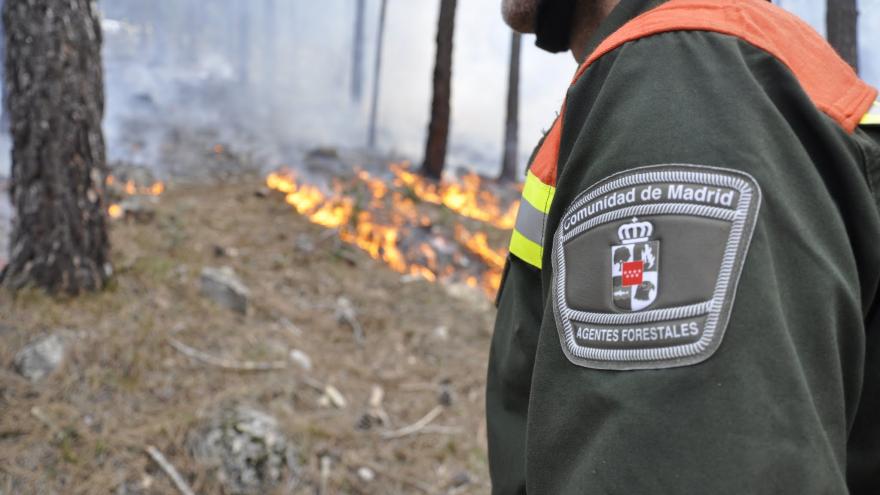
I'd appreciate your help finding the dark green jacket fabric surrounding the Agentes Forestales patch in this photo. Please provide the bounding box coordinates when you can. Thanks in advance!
[487,0,880,495]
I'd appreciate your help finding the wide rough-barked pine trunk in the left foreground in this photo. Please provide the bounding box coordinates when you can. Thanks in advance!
[0,0,111,294]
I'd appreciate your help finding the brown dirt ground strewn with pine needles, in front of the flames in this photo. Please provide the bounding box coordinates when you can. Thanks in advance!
[0,177,494,494]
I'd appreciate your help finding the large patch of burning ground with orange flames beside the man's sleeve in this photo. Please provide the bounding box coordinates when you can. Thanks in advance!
[266,165,518,294]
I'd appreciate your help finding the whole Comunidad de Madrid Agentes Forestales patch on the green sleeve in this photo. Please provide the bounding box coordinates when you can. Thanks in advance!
[551,165,761,370]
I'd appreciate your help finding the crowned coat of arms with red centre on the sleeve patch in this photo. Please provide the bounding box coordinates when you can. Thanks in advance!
[611,218,660,311]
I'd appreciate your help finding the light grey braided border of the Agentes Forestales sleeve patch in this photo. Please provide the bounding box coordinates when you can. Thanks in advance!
[551,164,761,371]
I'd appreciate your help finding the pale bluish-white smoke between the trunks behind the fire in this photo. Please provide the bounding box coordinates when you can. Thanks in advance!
[94,0,575,178]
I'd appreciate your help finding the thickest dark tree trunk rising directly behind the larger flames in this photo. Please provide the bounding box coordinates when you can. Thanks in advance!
[422,0,456,179]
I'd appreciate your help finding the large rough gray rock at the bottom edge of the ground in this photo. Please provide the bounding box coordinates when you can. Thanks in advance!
[187,405,298,495]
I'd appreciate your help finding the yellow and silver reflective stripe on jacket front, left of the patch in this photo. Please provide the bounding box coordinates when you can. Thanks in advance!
[510,171,556,269]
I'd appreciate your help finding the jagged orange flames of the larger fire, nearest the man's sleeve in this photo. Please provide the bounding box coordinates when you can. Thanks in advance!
[266,165,518,294]
